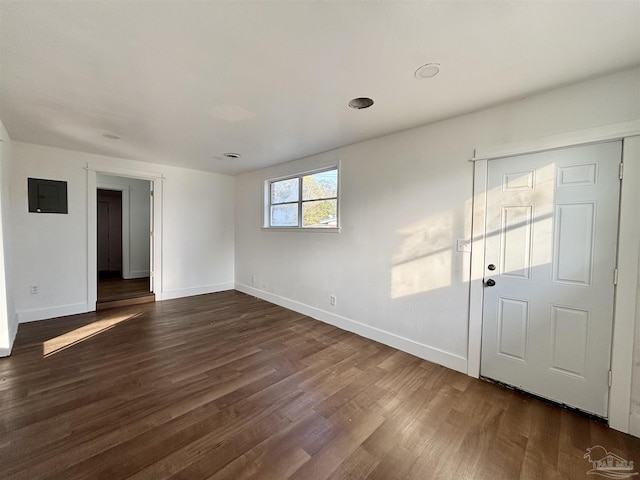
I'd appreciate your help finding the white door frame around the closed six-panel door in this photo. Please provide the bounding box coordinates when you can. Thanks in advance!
[467,120,640,433]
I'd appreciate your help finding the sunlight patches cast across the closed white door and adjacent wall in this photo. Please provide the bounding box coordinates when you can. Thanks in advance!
[391,163,555,298]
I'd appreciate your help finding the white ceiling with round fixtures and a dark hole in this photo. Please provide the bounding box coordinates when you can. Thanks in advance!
[0,0,640,174]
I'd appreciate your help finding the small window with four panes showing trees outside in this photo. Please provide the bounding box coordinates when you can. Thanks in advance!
[265,167,338,228]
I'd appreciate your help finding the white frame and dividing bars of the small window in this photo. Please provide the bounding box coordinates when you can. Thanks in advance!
[262,162,341,233]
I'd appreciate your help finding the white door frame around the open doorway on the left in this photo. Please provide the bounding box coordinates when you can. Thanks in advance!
[86,163,165,311]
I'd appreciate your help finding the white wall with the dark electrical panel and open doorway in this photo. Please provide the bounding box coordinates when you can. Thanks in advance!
[11,142,234,321]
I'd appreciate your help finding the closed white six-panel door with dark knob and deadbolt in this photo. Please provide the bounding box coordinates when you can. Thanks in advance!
[480,142,622,417]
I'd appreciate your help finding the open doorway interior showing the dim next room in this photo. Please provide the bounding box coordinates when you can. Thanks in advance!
[96,174,155,310]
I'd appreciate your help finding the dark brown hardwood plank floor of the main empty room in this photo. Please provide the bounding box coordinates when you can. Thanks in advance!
[0,292,640,480]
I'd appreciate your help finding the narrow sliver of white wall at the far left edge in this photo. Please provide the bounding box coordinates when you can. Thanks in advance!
[0,117,18,356]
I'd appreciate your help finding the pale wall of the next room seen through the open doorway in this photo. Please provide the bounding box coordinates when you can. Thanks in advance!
[97,173,151,278]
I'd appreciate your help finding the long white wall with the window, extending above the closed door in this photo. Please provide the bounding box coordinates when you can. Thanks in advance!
[236,69,640,388]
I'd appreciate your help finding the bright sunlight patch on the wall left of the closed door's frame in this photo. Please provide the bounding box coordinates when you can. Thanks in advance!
[391,212,453,298]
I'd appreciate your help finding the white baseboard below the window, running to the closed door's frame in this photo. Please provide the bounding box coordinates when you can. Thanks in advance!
[235,283,467,373]
